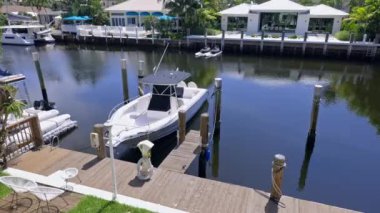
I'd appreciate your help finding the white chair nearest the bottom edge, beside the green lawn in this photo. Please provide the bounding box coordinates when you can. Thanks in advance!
[30,186,69,212]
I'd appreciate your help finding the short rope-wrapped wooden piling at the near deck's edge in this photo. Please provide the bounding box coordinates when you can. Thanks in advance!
[270,154,286,202]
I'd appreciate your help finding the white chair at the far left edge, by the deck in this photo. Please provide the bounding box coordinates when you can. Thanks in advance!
[0,176,38,208]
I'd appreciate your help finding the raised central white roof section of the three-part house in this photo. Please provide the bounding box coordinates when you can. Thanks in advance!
[250,0,309,12]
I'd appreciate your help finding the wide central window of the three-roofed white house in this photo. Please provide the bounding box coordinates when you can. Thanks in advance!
[260,13,298,32]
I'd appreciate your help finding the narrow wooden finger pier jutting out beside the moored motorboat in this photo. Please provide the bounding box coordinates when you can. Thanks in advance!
[159,130,200,173]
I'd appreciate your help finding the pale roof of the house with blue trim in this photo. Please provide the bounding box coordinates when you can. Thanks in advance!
[106,0,164,12]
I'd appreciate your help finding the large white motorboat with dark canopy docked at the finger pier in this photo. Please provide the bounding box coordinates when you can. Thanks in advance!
[108,71,207,147]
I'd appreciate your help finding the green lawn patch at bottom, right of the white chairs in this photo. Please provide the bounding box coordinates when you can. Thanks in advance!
[68,196,151,213]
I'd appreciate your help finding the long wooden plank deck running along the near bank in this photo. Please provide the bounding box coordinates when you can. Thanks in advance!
[9,147,358,213]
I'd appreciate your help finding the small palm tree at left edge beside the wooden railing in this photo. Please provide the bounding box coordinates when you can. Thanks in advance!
[0,85,24,168]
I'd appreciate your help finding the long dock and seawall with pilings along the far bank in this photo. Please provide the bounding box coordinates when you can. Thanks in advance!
[53,31,380,60]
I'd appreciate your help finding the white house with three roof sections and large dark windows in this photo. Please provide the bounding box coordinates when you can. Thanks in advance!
[219,0,348,35]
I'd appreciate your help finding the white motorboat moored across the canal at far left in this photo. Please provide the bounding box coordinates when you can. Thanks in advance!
[0,24,55,45]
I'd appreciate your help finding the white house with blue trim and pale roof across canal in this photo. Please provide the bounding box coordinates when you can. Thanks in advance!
[106,0,167,27]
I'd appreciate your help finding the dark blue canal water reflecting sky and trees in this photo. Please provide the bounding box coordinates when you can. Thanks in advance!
[0,45,380,212]
